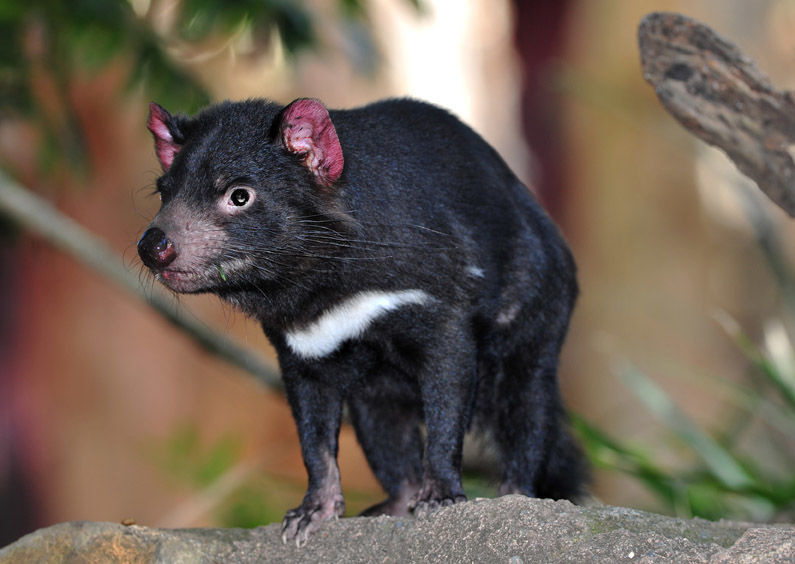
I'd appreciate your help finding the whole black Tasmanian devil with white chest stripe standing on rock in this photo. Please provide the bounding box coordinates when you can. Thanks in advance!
[138,99,586,543]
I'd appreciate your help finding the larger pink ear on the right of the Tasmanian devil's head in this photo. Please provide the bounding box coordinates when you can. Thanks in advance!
[281,98,345,186]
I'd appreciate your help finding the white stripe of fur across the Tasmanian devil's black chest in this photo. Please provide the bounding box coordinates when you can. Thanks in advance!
[286,290,431,358]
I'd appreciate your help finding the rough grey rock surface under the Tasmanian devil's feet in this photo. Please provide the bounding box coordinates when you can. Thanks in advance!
[0,496,795,564]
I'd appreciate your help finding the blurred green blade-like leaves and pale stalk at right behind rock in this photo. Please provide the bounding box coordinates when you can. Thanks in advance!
[573,169,795,521]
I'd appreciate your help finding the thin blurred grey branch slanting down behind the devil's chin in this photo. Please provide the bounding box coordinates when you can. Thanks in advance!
[0,170,281,388]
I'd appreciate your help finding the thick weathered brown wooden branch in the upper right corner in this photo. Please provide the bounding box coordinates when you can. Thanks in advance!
[638,13,795,217]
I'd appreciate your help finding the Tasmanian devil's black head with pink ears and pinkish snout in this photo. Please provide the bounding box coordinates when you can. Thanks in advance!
[138,99,343,292]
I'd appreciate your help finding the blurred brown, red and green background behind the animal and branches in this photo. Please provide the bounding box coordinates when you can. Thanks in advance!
[0,0,795,546]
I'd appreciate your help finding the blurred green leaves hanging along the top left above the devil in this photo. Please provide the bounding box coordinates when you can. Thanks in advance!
[0,0,419,178]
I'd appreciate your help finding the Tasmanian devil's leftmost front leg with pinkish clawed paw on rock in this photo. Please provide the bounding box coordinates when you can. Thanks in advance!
[282,368,345,545]
